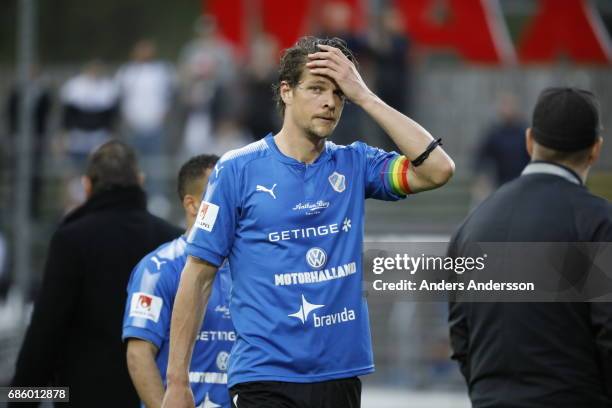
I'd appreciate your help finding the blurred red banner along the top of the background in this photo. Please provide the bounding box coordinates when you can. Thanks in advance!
[205,0,612,64]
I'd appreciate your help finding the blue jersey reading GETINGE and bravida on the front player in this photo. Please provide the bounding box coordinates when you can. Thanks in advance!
[186,134,403,387]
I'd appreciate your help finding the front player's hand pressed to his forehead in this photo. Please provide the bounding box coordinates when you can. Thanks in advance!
[306,44,371,104]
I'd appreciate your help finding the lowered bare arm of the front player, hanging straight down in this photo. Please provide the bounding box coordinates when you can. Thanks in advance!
[162,256,217,408]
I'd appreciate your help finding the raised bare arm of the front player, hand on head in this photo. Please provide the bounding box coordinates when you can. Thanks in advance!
[306,44,455,193]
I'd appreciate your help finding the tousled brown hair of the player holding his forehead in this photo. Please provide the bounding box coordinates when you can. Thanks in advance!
[272,37,357,116]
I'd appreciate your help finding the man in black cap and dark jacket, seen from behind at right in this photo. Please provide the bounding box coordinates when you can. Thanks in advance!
[449,88,612,408]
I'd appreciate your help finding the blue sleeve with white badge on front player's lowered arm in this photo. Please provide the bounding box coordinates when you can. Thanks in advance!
[186,158,240,266]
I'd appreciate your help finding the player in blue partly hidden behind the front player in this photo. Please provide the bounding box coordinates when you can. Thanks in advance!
[123,155,235,408]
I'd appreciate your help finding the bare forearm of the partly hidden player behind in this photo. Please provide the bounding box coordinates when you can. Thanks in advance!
[127,338,164,408]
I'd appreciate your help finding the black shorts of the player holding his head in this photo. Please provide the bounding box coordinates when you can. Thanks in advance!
[230,377,361,408]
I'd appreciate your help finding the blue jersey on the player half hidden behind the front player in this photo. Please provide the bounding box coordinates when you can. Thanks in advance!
[122,237,236,408]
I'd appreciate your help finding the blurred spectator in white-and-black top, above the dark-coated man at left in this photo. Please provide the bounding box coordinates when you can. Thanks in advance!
[60,61,118,169]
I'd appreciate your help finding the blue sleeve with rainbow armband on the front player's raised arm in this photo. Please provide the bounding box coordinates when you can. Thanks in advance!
[353,142,408,201]
